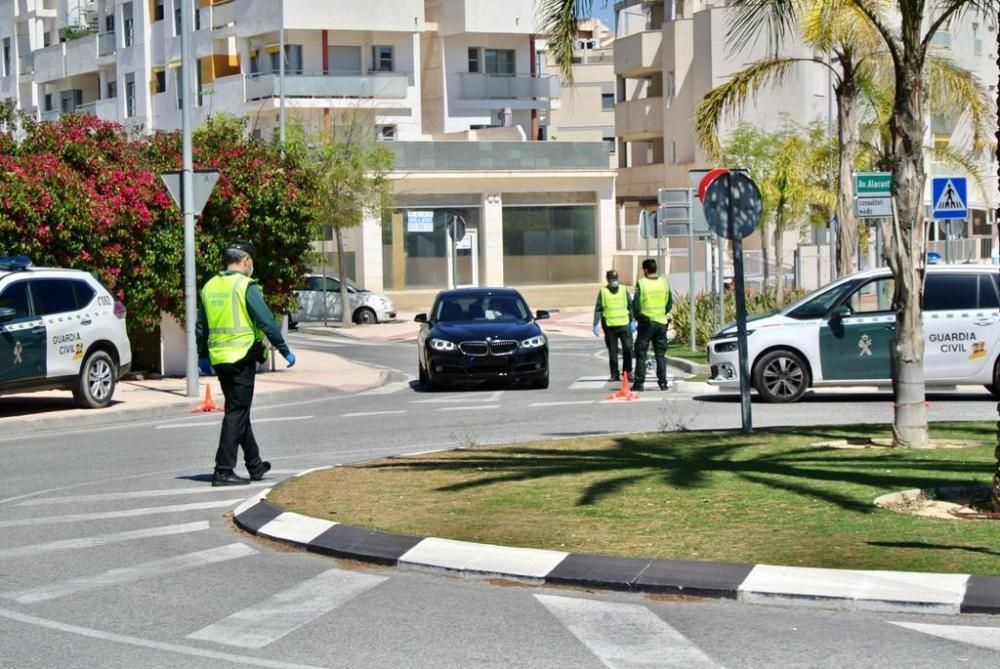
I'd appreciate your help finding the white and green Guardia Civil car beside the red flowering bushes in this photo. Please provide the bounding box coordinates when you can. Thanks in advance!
[0,256,132,408]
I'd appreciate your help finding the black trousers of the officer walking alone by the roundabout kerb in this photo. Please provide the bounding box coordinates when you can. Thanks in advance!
[215,354,260,471]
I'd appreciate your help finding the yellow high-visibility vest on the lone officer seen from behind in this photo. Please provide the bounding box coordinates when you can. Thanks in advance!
[201,272,261,365]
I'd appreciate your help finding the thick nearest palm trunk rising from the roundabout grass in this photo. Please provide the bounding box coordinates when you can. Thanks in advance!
[888,53,928,447]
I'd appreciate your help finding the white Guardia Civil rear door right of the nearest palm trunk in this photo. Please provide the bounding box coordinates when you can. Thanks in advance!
[923,272,1000,381]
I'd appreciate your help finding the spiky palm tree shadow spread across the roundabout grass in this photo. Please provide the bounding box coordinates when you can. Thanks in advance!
[361,427,989,513]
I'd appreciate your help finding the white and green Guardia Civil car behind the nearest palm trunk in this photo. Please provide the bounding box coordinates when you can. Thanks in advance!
[708,265,1000,402]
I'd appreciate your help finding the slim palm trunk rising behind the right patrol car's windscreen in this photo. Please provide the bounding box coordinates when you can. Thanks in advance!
[835,76,858,276]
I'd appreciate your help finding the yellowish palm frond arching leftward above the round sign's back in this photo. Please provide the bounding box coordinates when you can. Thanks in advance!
[695,58,815,158]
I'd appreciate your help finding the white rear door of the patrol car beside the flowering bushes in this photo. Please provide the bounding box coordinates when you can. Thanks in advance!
[29,278,87,379]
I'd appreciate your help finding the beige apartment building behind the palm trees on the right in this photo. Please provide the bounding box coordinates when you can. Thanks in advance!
[614,0,1000,272]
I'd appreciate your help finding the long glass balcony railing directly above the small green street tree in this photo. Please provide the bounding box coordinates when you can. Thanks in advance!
[246,72,409,100]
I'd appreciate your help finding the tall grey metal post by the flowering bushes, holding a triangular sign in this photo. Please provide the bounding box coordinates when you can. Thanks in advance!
[181,0,198,397]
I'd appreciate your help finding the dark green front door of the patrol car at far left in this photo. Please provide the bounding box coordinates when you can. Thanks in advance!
[0,280,46,389]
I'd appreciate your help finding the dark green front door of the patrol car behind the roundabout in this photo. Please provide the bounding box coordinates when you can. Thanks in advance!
[819,276,896,381]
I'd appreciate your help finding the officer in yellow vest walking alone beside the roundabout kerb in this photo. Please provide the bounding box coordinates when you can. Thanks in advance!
[195,241,295,486]
